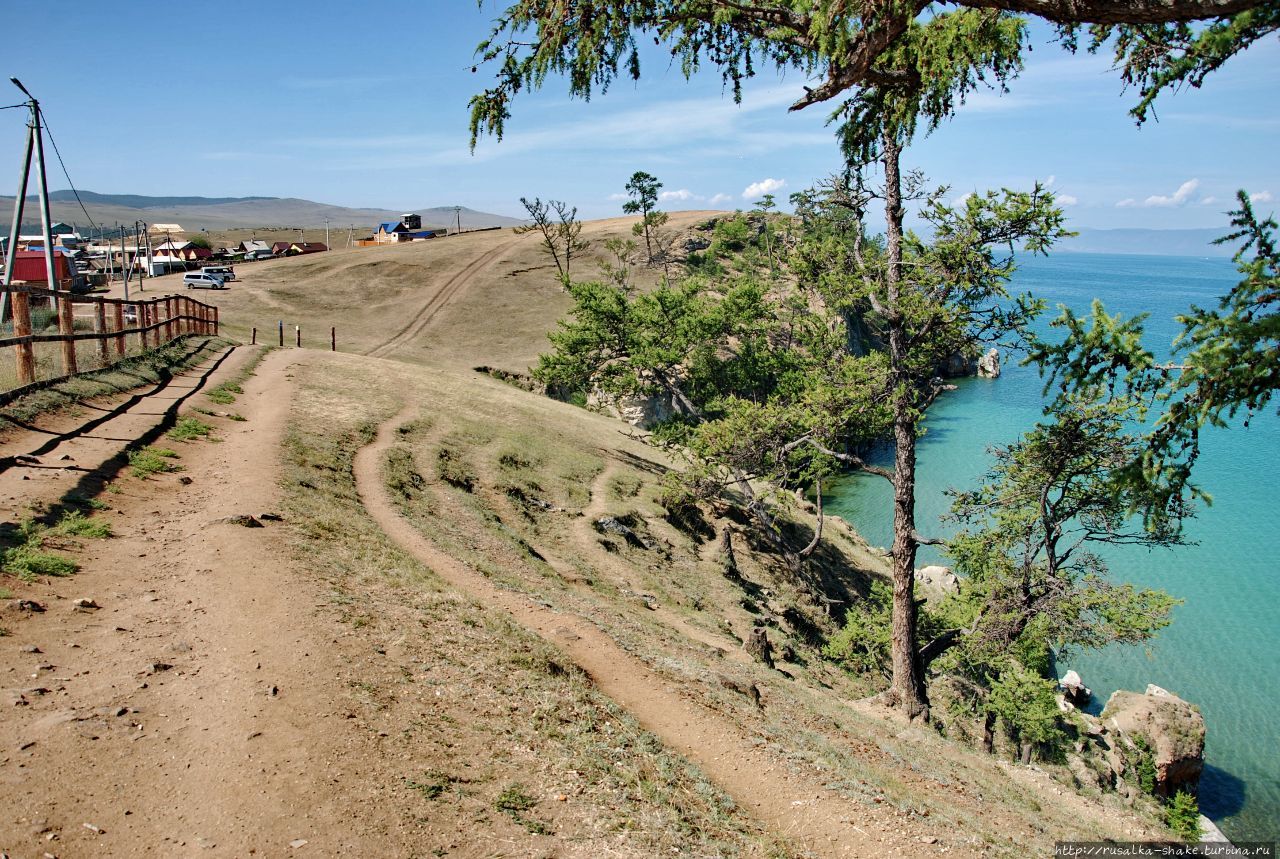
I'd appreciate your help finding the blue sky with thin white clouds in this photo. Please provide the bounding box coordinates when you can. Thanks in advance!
[0,0,1280,228]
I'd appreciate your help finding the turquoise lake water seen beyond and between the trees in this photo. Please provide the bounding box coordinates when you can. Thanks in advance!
[828,253,1280,840]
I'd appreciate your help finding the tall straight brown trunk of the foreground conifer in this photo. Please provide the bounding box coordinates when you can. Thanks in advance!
[881,133,929,721]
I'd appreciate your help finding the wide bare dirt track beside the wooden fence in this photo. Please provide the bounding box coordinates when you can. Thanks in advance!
[0,349,407,856]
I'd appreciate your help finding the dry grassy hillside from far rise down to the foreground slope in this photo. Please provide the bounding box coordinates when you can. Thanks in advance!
[87,213,1177,856]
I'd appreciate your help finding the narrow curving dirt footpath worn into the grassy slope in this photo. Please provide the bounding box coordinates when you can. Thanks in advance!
[355,405,963,856]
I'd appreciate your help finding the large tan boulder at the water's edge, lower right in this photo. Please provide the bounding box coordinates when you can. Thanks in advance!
[1102,686,1204,796]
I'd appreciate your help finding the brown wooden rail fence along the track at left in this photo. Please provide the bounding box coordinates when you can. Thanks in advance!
[0,284,218,402]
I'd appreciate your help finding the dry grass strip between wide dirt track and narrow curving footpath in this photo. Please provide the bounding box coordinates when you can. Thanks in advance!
[285,357,796,856]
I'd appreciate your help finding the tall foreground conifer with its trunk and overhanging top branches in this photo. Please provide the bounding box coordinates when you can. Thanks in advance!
[471,0,1264,717]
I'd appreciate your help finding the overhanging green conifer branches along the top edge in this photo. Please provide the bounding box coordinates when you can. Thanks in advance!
[471,0,1264,145]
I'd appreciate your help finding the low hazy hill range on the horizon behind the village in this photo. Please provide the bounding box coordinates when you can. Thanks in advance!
[0,191,524,234]
